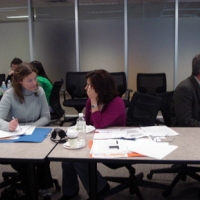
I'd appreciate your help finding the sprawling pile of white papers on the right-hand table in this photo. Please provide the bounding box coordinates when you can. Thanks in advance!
[90,126,178,159]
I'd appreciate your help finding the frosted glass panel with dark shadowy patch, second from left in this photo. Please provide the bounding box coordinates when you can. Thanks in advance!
[33,0,76,82]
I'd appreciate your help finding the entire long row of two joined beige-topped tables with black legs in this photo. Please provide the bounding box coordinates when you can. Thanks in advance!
[0,127,200,200]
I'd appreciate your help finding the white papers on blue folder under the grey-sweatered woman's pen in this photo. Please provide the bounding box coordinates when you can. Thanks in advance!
[0,125,35,139]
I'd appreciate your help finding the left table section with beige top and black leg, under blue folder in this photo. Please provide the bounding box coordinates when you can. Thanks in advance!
[0,131,56,200]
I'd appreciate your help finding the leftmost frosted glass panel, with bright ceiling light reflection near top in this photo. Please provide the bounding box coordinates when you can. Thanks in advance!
[0,0,29,76]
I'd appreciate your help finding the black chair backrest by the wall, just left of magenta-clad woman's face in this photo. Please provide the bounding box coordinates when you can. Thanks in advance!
[65,72,88,99]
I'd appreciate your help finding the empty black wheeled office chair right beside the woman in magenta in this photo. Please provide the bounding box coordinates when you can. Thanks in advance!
[101,92,167,200]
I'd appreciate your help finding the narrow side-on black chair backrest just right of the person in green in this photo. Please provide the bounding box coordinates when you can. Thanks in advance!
[49,79,65,119]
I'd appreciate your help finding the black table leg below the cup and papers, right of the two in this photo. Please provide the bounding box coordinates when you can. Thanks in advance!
[89,162,98,200]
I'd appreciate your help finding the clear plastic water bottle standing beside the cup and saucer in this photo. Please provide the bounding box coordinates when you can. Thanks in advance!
[76,113,86,147]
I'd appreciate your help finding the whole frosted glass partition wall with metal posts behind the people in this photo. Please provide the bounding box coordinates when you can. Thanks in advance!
[0,0,200,91]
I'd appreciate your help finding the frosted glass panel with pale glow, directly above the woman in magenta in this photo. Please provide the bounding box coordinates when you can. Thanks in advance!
[79,0,124,72]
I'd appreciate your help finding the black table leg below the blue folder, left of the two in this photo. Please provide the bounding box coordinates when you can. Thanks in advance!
[28,163,38,200]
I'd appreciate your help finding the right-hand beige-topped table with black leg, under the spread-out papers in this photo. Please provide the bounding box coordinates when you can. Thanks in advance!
[48,128,200,200]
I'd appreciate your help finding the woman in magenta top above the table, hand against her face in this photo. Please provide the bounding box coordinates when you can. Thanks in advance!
[85,70,126,128]
